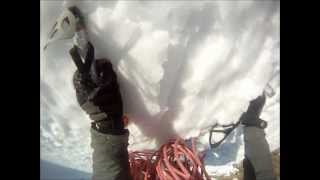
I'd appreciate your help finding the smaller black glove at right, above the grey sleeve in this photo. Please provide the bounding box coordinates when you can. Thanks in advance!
[240,94,267,129]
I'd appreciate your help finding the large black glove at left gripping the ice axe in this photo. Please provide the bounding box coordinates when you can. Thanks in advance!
[70,43,125,135]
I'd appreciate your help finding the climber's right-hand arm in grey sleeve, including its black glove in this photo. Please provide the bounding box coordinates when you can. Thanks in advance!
[241,95,275,180]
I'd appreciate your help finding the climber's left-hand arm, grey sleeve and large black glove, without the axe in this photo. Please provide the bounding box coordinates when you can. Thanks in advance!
[70,36,130,180]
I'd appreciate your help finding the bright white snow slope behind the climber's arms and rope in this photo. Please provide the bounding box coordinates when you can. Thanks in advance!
[40,1,280,174]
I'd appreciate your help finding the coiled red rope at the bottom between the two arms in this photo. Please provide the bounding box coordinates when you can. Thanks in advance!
[129,138,210,180]
